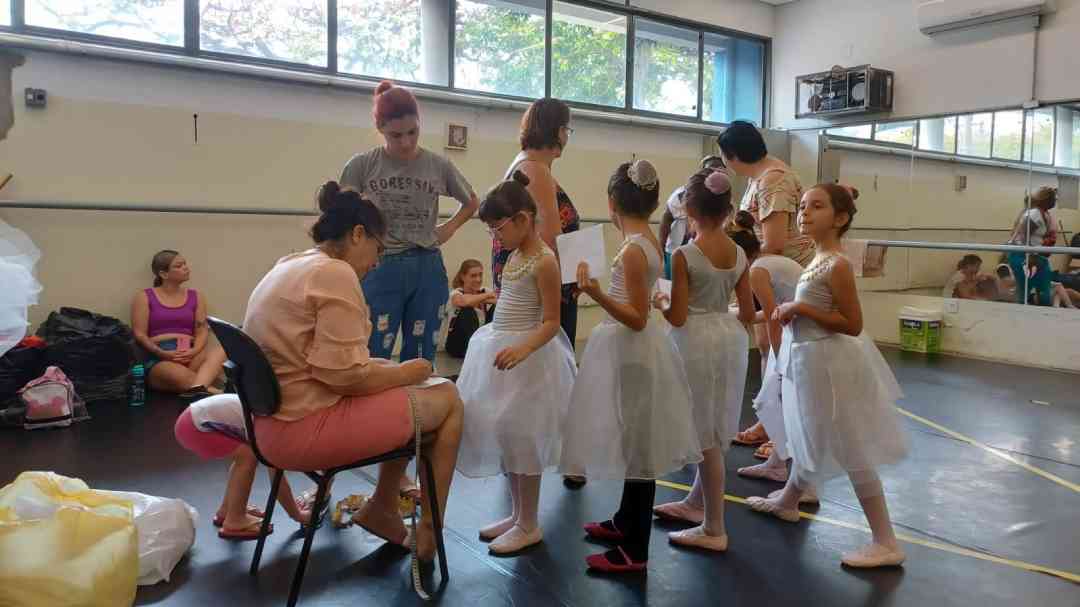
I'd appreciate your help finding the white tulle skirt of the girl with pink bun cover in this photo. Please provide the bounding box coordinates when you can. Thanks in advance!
[669,314,750,450]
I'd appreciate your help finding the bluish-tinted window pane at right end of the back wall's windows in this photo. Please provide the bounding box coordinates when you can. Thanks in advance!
[701,33,765,126]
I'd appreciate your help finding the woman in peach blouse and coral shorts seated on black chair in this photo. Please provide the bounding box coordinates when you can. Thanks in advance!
[244,181,462,561]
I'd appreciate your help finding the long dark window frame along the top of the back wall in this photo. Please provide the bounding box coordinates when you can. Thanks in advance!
[0,0,772,127]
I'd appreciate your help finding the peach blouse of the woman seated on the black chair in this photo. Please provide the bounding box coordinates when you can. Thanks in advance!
[244,248,372,421]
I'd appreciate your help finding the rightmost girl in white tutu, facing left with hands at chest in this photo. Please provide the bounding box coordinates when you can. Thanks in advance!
[747,184,907,567]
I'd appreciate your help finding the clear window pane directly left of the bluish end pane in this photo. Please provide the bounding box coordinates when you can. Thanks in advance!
[634,19,698,116]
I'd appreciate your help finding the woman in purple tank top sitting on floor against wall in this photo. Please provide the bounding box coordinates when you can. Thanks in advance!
[132,249,225,399]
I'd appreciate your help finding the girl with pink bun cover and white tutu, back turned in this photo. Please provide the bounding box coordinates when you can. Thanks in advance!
[653,170,754,552]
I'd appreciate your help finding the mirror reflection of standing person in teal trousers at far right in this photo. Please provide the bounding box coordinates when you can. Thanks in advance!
[1008,187,1057,306]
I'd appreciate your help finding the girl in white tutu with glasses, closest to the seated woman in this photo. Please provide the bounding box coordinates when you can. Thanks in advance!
[458,171,577,554]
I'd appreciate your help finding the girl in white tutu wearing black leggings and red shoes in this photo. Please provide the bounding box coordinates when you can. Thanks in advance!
[559,160,701,572]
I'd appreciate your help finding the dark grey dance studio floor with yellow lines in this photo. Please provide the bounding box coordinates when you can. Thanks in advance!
[0,350,1080,607]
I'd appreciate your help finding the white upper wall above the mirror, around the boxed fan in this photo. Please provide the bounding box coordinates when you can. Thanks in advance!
[771,0,1080,127]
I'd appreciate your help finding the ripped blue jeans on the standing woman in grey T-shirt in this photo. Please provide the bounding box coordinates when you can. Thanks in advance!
[361,248,450,364]
